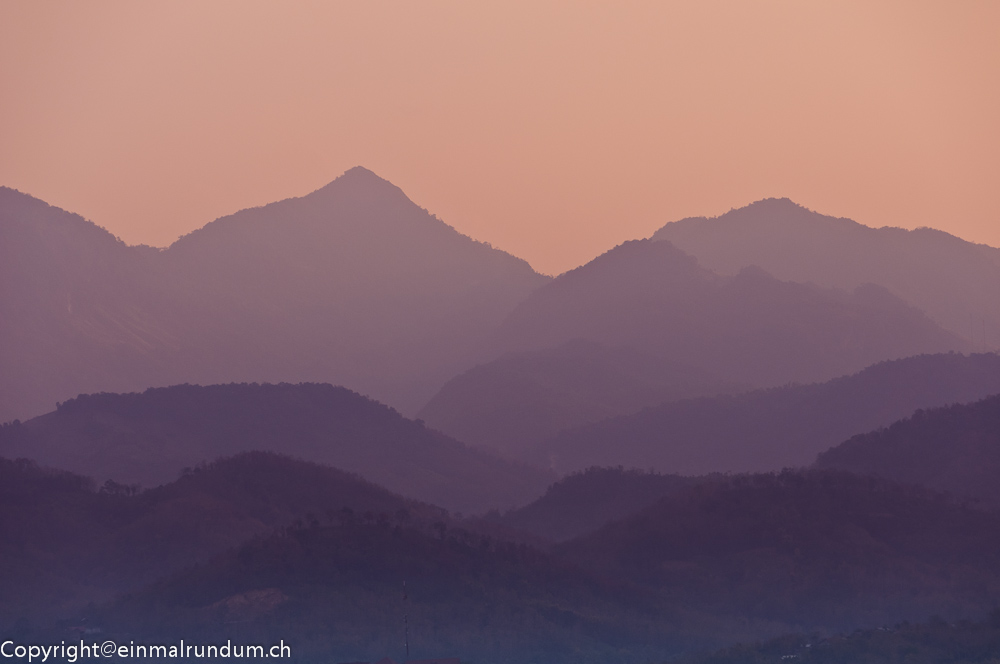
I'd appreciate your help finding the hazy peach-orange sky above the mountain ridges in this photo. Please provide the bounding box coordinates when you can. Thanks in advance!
[0,0,1000,273]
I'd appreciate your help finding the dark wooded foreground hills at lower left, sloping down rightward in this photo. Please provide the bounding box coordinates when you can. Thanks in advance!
[0,452,752,664]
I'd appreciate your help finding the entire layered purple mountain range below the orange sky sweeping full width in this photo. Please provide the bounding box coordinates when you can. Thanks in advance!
[0,167,1000,664]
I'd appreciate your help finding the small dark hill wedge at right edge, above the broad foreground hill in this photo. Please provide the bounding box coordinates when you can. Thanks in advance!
[816,395,1000,507]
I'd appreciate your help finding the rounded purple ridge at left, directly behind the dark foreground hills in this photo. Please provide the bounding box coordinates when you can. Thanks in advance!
[0,384,552,511]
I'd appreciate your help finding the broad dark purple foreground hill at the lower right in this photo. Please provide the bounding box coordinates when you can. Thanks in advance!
[553,471,1000,630]
